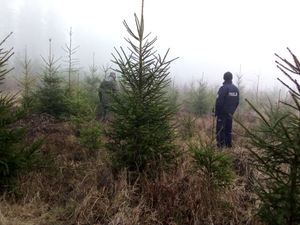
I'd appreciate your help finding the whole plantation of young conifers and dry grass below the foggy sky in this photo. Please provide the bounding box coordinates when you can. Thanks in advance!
[0,0,300,225]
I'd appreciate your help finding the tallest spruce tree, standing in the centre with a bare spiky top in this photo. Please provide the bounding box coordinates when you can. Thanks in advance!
[107,1,176,176]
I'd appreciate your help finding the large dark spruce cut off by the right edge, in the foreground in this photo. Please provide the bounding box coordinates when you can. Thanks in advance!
[242,50,300,225]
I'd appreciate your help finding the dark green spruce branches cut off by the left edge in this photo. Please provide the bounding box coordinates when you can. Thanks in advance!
[0,34,41,191]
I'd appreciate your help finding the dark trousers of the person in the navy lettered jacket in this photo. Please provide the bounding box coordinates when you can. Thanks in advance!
[216,114,232,148]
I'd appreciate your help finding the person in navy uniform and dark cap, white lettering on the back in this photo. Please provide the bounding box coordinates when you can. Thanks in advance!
[215,72,240,148]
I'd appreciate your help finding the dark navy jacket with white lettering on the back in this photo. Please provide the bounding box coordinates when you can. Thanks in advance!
[215,81,240,116]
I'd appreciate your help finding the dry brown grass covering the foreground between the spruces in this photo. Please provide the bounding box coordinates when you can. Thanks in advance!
[0,116,259,225]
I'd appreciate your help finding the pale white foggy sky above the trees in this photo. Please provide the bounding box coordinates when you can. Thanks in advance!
[0,0,300,89]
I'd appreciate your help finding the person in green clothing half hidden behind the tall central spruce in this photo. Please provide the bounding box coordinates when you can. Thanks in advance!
[99,72,117,121]
